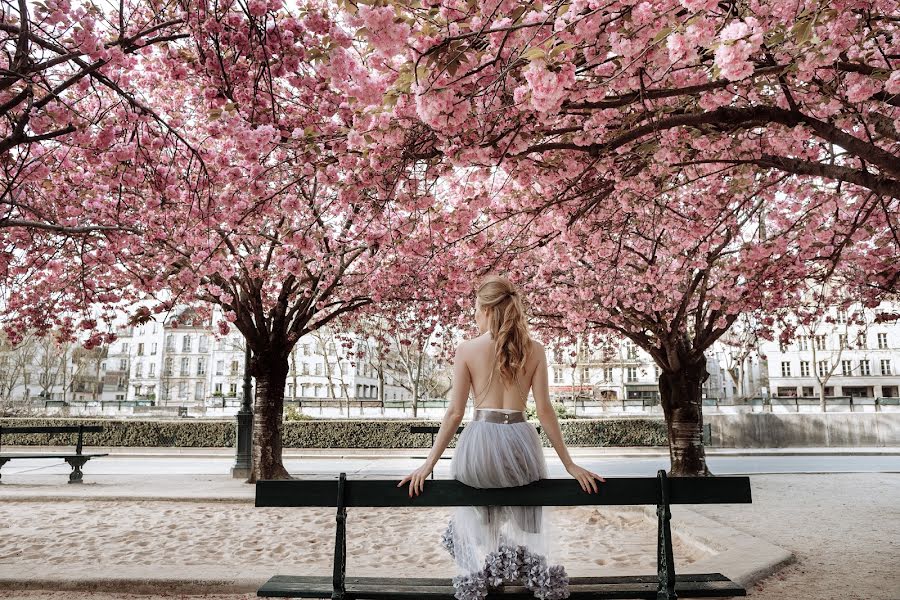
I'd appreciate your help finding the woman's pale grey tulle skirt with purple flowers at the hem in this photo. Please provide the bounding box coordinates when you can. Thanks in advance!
[441,370,569,600]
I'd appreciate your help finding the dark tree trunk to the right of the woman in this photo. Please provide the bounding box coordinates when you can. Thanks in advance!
[659,358,712,477]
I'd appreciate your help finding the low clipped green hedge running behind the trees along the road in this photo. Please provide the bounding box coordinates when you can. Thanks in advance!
[0,418,668,448]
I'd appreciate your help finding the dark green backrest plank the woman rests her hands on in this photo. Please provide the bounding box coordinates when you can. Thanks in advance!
[256,476,752,507]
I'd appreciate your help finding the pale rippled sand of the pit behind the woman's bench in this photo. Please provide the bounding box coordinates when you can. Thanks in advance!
[0,500,706,577]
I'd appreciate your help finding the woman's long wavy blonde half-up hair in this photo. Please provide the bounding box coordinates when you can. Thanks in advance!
[476,275,531,386]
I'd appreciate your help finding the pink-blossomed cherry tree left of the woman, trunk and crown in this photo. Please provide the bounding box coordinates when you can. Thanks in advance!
[4,0,428,482]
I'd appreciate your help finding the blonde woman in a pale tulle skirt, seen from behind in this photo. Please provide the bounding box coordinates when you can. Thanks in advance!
[397,275,605,600]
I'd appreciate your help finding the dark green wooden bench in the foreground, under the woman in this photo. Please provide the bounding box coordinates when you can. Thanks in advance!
[255,470,751,600]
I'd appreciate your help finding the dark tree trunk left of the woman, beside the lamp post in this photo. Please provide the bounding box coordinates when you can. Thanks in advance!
[247,353,291,483]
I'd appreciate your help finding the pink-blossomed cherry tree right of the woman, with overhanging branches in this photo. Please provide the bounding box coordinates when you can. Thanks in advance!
[345,0,900,475]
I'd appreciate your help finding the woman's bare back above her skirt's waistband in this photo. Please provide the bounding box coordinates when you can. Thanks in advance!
[465,333,539,411]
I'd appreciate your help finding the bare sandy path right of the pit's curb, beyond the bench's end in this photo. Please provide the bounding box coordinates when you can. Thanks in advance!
[691,473,900,600]
